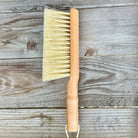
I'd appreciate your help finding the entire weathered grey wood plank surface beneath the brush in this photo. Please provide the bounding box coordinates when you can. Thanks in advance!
[0,0,138,138]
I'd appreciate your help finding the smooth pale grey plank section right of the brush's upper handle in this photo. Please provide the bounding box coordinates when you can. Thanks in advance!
[80,6,138,56]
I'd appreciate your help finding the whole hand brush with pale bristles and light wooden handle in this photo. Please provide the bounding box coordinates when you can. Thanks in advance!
[43,9,79,132]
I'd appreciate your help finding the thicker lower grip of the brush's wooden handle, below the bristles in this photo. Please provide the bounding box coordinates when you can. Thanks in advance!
[67,78,78,132]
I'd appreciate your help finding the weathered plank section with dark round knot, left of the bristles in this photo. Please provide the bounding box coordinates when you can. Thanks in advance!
[0,13,43,58]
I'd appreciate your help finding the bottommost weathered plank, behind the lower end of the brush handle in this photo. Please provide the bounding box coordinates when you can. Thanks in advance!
[0,109,138,138]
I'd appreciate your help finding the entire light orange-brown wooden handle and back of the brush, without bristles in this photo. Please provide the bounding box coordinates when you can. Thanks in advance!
[67,9,79,132]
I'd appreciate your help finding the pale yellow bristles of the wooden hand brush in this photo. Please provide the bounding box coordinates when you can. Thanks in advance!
[42,9,70,81]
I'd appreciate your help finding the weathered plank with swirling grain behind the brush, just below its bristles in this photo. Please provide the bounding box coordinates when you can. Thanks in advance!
[0,56,138,108]
